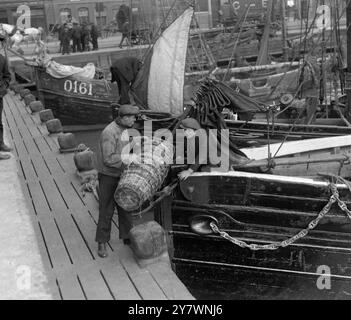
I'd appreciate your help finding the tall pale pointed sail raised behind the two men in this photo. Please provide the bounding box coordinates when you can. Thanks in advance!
[132,7,194,115]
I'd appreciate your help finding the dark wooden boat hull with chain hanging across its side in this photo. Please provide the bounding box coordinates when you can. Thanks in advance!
[158,172,351,299]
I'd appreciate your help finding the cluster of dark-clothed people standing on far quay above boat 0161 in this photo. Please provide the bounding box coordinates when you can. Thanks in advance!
[59,22,99,55]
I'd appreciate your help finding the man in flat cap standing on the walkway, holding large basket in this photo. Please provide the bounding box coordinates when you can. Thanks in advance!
[95,105,139,258]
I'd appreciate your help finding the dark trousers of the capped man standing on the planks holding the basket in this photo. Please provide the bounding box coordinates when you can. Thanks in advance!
[95,173,134,243]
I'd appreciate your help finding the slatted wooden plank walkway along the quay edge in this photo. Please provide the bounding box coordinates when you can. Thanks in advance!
[4,93,193,300]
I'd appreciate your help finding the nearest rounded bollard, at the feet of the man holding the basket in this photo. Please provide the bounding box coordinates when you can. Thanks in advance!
[129,221,167,259]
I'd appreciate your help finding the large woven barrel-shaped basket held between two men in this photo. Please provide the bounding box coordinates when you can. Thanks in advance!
[115,139,173,211]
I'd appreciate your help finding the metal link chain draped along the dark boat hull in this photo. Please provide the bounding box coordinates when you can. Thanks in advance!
[210,183,351,251]
